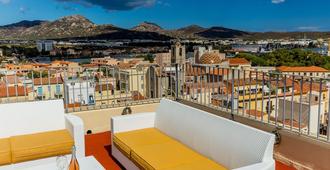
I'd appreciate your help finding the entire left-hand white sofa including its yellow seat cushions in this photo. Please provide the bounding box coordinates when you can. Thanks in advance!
[0,100,85,169]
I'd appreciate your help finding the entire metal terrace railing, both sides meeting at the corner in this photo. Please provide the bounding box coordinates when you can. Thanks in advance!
[0,64,330,142]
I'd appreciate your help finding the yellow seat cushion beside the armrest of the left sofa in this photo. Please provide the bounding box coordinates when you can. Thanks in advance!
[10,130,74,163]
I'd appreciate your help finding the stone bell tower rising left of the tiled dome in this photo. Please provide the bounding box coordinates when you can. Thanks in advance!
[171,42,186,64]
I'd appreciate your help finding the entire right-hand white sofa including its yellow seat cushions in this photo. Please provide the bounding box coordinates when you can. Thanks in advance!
[111,99,275,170]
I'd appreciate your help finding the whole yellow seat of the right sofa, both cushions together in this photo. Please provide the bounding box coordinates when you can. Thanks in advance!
[113,128,226,170]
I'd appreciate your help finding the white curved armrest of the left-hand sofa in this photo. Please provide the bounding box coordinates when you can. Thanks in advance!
[65,115,85,157]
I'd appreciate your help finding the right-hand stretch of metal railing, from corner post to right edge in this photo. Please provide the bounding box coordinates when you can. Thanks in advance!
[179,65,330,142]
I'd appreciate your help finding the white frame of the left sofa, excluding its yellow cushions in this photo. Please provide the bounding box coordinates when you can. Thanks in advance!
[0,100,85,170]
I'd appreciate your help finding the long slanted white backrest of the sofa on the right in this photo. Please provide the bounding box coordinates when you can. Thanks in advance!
[155,99,274,169]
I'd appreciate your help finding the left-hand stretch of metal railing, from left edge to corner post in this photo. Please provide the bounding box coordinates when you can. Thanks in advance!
[0,65,175,112]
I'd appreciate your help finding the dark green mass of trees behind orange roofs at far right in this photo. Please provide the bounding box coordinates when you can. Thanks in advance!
[236,49,330,69]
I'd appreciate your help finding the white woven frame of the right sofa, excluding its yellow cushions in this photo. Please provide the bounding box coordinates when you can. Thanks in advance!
[111,99,275,170]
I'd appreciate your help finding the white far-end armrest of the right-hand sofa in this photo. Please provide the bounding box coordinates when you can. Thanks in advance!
[111,112,156,134]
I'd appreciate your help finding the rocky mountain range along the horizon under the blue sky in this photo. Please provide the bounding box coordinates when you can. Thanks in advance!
[0,15,330,40]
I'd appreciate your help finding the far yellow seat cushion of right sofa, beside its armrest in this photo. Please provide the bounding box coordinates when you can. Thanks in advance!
[113,128,173,158]
